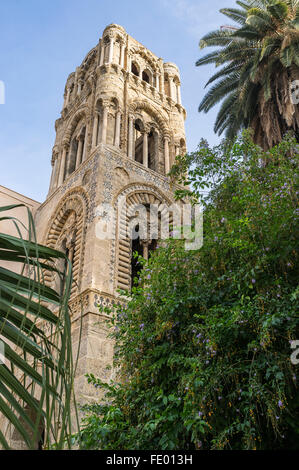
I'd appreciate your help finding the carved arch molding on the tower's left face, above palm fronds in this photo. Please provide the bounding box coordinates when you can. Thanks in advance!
[45,187,90,297]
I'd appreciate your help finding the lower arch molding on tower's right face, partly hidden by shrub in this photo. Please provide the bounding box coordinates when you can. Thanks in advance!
[112,183,173,291]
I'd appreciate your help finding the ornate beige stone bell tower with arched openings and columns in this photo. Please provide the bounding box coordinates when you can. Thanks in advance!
[36,24,186,403]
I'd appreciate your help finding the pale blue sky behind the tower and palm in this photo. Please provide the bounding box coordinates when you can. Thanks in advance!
[0,0,235,201]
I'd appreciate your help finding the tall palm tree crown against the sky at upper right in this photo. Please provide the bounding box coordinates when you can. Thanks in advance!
[196,0,299,150]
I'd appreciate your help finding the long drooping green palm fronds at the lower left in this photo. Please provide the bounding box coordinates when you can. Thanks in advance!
[0,205,78,449]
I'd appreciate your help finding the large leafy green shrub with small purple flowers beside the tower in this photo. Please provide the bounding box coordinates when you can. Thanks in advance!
[82,134,299,450]
